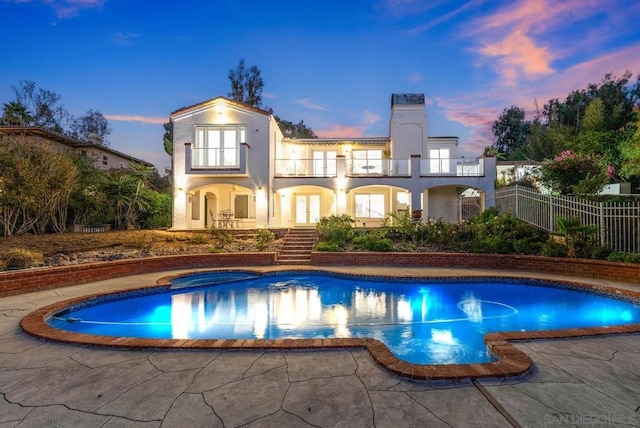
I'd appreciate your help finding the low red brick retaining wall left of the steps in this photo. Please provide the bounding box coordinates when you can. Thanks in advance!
[0,253,276,296]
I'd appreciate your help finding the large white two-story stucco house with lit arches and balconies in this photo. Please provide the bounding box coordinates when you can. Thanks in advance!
[171,94,496,230]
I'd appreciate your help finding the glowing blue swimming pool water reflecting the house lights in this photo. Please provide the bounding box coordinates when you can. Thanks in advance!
[49,272,640,364]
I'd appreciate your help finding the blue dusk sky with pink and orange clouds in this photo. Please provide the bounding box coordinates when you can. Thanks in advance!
[0,0,640,173]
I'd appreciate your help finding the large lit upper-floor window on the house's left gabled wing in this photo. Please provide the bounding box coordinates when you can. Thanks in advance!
[191,126,247,168]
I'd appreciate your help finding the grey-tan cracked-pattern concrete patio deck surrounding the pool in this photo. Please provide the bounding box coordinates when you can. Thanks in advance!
[0,268,640,427]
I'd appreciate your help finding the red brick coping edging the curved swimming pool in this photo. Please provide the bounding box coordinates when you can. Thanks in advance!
[20,267,640,380]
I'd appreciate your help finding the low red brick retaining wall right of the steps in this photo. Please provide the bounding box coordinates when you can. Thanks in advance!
[311,251,640,284]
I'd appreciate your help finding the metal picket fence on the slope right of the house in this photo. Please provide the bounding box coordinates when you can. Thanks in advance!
[495,185,640,253]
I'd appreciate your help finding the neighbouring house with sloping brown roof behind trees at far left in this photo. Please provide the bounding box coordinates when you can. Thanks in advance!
[0,126,154,171]
